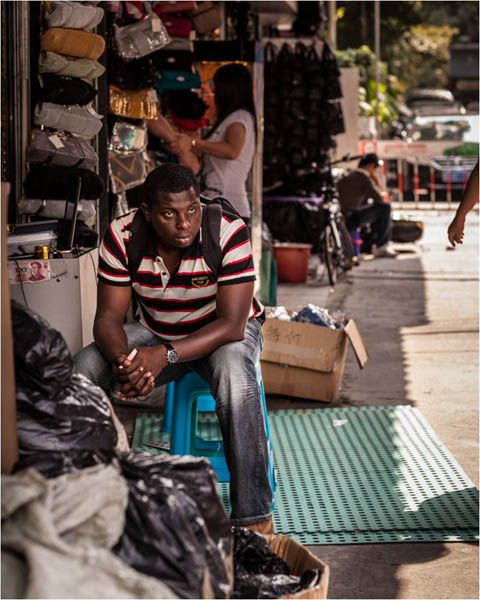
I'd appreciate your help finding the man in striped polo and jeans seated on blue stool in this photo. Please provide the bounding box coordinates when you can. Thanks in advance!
[75,164,273,533]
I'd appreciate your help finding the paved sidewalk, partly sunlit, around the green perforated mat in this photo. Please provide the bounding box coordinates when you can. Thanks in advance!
[269,211,479,599]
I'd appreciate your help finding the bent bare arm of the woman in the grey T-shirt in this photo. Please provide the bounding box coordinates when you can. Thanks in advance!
[169,123,246,160]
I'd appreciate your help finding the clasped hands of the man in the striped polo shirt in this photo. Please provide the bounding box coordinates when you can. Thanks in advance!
[113,346,167,400]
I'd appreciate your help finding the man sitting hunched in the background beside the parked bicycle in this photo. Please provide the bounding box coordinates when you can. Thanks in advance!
[337,154,397,258]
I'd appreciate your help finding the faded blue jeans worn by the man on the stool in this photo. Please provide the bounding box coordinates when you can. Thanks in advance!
[75,319,273,525]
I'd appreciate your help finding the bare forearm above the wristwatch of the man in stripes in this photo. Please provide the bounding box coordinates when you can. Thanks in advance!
[172,318,245,362]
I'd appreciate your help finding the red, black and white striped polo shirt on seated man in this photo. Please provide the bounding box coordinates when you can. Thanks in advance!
[98,209,263,340]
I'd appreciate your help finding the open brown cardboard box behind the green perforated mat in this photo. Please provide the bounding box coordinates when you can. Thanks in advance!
[262,319,368,402]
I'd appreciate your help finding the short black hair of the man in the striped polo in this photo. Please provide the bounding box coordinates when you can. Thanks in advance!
[143,163,200,206]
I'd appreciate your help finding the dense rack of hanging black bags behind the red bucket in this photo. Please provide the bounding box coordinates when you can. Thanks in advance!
[263,41,345,191]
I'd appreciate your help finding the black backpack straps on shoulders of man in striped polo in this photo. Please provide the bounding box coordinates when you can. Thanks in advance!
[126,196,241,281]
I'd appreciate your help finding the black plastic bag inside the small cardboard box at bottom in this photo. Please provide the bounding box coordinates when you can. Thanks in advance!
[232,527,321,598]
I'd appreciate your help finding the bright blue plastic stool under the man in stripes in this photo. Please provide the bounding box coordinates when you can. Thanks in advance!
[163,369,277,492]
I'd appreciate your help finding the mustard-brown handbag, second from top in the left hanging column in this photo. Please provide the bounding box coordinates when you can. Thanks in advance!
[42,27,105,60]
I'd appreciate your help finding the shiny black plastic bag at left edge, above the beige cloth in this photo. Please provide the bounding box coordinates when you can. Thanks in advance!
[12,302,117,477]
